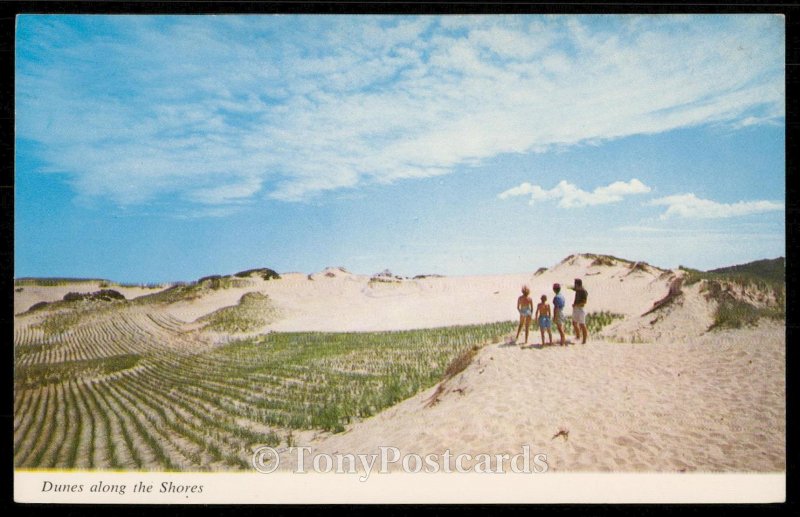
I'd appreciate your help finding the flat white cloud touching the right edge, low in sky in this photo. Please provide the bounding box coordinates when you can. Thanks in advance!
[649,194,785,220]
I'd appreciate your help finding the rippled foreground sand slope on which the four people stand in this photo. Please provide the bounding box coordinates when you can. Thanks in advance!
[282,324,785,472]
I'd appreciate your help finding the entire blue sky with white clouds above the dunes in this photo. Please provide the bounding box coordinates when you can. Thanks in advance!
[15,15,785,282]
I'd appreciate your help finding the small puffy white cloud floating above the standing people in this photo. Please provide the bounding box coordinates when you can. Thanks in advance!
[498,178,650,208]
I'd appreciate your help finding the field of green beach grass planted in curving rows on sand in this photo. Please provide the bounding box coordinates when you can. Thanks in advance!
[14,306,513,471]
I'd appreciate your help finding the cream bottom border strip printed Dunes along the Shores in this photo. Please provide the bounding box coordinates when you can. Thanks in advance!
[14,470,786,504]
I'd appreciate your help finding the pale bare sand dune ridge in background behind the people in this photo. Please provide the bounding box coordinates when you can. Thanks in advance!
[14,256,669,331]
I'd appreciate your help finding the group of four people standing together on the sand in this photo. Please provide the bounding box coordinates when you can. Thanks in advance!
[514,278,589,346]
